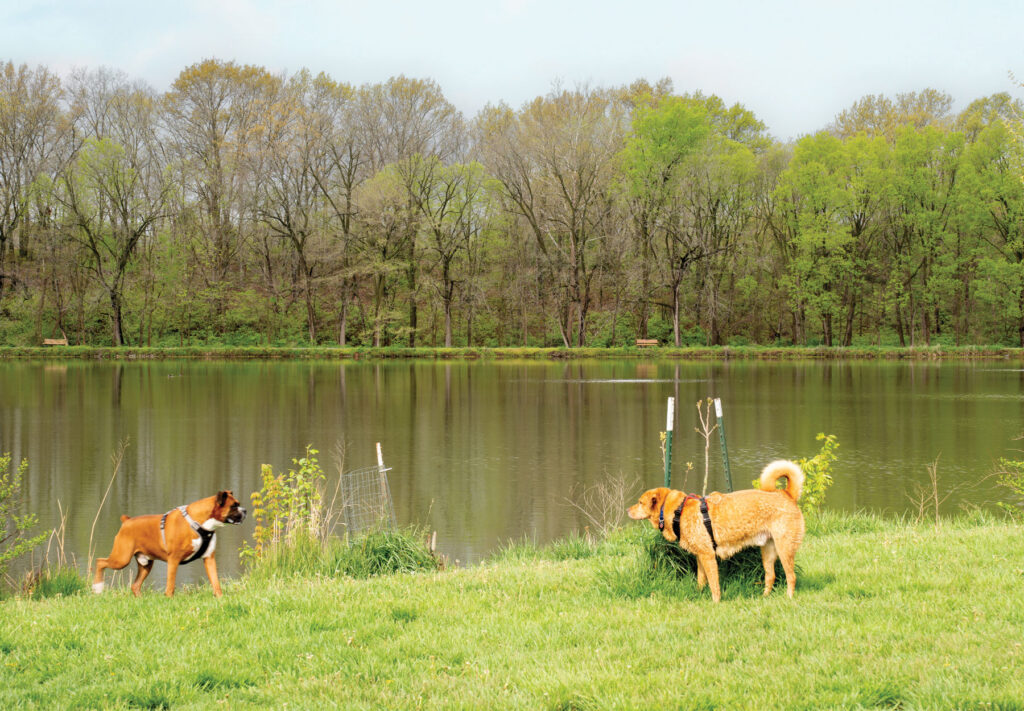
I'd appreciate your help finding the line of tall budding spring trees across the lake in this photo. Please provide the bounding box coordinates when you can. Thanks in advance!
[0,59,1024,346]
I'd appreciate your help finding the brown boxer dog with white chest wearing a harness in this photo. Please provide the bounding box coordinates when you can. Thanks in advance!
[92,491,246,597]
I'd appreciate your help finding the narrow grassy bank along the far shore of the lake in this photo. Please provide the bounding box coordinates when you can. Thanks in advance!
[6,345,1024,361]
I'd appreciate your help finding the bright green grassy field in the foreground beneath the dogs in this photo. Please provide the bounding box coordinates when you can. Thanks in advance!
[0,517,1024,709]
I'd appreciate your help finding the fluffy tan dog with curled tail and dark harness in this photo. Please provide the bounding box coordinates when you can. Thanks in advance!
[630,460,804,602]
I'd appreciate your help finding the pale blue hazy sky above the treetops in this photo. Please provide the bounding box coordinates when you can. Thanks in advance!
[0,0,1024,140]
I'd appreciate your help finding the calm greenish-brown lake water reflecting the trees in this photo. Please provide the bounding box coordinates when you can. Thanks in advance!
[0,361,1024,589]
